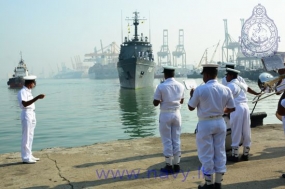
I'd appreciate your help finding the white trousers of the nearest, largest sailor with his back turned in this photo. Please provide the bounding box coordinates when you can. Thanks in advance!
[196,118,227,175]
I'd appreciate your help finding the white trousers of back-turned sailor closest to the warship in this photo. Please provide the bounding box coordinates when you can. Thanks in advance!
[159,110,181,157]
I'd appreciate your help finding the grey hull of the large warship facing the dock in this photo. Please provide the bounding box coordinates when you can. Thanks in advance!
[117,58,154,89]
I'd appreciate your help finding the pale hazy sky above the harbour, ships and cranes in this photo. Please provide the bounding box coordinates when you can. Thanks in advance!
[0,0,285,78]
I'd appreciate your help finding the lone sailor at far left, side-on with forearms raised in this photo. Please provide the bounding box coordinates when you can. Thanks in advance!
[18,75,45,164]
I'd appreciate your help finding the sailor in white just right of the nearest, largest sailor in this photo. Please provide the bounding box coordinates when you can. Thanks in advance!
[226,68,251,162]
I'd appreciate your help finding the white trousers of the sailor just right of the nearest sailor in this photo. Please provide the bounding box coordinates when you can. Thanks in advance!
[227,103,251,147]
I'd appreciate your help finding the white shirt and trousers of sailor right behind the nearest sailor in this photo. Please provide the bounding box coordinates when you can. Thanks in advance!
[227,79,251,148]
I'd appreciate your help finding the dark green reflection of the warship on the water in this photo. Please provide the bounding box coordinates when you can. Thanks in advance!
[119,88,156,138]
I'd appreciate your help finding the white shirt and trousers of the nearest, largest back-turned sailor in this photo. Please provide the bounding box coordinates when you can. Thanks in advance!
[188,80,235,175]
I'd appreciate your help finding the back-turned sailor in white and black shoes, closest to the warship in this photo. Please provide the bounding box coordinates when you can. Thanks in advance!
[153,66,185,173]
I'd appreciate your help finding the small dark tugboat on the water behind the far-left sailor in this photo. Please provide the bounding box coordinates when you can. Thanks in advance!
[7,53,29,88]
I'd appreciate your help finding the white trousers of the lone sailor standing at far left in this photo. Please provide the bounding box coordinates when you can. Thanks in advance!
[21,110,36,161]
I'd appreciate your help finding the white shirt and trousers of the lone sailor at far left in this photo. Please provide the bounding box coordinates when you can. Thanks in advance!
[18,86,36,161]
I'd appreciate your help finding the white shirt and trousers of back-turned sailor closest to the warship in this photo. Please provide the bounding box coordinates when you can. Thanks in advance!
[153,78,185,157]
